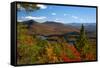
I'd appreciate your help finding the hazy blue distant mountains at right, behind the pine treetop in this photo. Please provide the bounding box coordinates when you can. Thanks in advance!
[65,23,96,39]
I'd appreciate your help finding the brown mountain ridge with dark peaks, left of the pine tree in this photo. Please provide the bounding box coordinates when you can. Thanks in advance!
[23,20,79,35]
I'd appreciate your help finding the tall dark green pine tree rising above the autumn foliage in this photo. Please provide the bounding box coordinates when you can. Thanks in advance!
[75,24,89,58]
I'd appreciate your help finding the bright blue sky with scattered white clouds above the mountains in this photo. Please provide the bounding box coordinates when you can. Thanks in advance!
[17,4,96,24]
